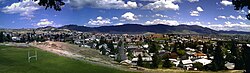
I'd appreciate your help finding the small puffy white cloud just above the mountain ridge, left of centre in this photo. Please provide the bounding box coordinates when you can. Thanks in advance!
[88,16,112,26]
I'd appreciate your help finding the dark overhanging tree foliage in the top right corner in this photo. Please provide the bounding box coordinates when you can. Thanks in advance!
[232,0,250,20]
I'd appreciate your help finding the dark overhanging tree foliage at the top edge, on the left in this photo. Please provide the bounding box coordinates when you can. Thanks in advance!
[23,0,65,11]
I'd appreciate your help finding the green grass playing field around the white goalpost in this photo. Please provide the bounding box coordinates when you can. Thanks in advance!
[0,46,135,73]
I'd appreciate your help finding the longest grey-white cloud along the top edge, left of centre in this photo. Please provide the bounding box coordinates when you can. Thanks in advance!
[68,0,138,9]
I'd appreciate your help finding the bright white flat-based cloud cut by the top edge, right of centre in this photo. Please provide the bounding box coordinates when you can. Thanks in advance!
[143,0,179,10]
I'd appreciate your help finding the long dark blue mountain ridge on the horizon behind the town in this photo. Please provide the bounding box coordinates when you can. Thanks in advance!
[56,24,250,34]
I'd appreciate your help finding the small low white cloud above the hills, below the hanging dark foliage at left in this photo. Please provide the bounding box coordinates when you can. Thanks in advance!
[34,19,56,27]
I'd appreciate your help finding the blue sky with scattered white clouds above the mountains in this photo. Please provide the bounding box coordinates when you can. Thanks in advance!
[0,0,250,32]
